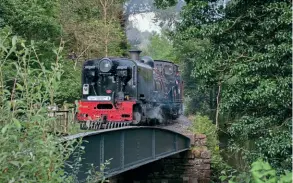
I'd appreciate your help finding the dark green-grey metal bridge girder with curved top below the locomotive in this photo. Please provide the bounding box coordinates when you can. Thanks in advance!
[65,127,190,180]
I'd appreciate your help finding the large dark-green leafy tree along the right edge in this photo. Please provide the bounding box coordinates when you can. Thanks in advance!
[217,1,292,171]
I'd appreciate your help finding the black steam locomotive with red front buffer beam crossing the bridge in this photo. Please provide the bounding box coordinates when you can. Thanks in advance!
[77,50,183,129]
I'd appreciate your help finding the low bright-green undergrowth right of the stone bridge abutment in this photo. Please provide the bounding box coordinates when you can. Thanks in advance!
[190,114,292,183]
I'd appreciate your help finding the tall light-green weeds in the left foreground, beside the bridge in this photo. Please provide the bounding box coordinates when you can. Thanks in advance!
[0,28,107,183]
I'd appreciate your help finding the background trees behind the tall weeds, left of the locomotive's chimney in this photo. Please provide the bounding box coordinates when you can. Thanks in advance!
[0,0,128,104]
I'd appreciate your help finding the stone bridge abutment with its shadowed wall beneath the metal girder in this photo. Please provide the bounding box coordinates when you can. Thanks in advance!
[110,134,211,183]
